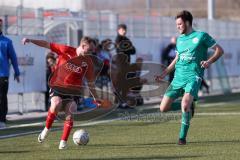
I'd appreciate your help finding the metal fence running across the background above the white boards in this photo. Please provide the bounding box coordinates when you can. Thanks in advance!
[2,7,240,41]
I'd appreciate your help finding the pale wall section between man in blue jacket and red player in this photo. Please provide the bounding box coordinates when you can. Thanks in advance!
[8,36,46,93]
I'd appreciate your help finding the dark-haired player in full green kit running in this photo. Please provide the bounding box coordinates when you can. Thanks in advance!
[156,11,223,145]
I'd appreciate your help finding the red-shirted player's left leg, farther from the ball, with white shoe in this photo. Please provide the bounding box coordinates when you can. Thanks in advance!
[38,96,62,143]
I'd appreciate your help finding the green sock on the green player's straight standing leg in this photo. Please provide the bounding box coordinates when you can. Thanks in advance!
[179,112,191,139]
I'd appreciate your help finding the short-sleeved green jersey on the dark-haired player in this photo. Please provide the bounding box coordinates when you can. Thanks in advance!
[173,31,216,87]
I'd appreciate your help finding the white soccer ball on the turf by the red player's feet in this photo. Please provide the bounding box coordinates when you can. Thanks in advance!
[73,129,89,146]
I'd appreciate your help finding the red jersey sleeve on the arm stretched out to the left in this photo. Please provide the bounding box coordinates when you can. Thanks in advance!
[50,43,76,56]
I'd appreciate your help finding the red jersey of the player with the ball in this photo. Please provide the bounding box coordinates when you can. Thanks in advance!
[49,43,95,94]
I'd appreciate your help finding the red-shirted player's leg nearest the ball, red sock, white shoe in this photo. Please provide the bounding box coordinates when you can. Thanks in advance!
[59,100,77,149]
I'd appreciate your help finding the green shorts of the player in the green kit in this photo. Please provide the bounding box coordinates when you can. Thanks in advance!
[164,80,202,101]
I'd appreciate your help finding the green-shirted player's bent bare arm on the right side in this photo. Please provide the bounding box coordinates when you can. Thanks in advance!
[201,44,224,68]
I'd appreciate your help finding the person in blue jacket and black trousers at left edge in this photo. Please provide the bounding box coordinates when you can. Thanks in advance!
[0,19,20,128]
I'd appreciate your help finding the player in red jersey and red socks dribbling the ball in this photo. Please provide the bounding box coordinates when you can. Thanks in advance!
[22,37,97,149]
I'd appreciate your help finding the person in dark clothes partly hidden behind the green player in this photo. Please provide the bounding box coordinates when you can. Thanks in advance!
[162,37,176,82]
